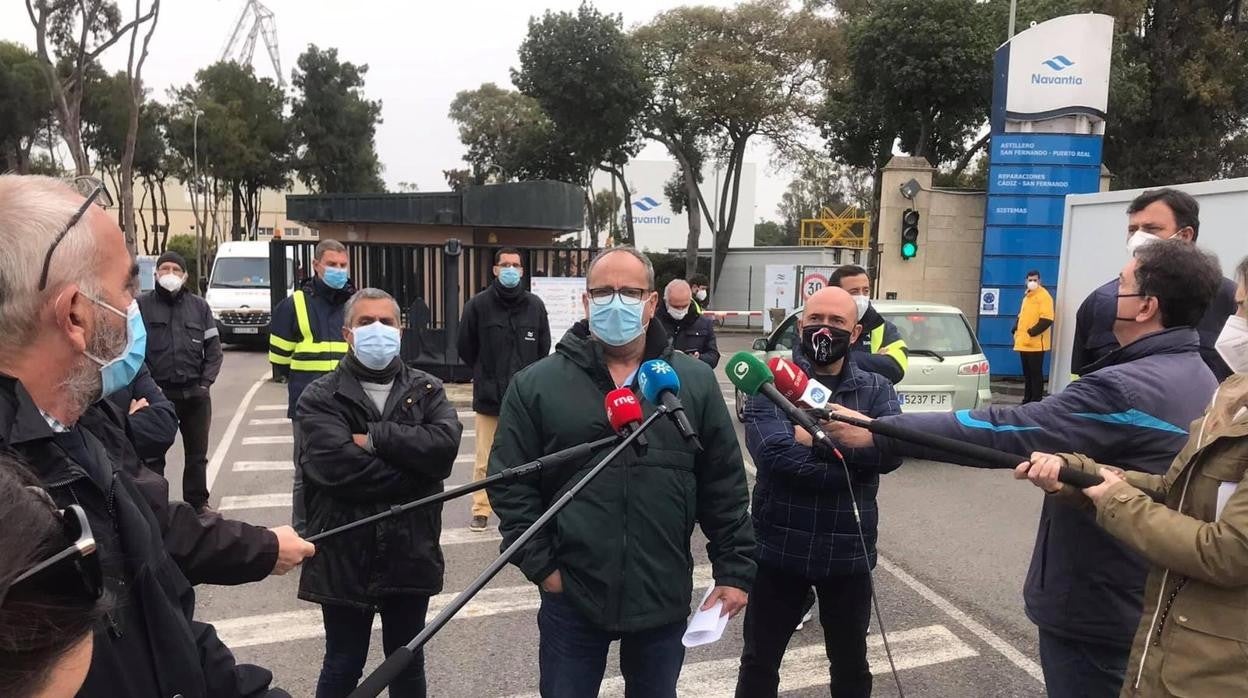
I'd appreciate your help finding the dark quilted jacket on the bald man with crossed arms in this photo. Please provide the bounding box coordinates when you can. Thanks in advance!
[745,356,901,581]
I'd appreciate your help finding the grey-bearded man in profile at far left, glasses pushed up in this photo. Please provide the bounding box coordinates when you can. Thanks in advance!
[0,176,294,698]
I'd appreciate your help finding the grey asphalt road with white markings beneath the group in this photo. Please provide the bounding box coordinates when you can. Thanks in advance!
[168,336,1043,698]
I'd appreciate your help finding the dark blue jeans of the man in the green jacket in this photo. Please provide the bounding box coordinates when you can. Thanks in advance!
[538,592,685,698]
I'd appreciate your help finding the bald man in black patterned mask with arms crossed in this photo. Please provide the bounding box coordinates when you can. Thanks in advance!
[736,286,901,698]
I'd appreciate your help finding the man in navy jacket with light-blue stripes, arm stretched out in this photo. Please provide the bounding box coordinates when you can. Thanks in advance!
[829,241,1222,698]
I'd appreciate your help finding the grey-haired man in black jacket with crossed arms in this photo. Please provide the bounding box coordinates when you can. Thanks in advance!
[297,288,463,698]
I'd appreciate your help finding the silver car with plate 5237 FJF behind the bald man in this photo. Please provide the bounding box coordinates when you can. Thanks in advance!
[736,301,992,420]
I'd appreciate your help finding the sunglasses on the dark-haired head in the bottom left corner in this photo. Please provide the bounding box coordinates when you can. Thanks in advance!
[0,504,104,604]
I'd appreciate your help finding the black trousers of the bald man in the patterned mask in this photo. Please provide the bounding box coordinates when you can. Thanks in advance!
[736,563,871,698]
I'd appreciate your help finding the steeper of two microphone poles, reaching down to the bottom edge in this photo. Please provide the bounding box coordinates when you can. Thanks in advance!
[348,407,668,698]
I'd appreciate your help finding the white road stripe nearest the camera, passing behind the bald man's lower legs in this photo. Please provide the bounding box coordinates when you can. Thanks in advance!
[512,626,978,698]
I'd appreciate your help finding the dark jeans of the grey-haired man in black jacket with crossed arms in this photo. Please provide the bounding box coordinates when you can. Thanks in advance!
[316,596,429,698]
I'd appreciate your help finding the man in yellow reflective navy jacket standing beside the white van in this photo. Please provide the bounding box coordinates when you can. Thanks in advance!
[268,240,356,536]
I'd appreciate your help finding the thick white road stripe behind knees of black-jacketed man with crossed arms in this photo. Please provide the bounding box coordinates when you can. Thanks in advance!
[212,564,713,649]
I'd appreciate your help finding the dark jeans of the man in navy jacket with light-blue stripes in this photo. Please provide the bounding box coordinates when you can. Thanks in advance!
[1040,631,1131,698]
